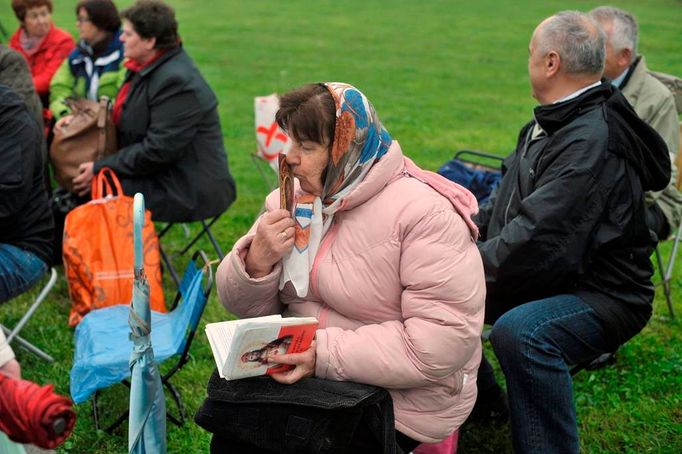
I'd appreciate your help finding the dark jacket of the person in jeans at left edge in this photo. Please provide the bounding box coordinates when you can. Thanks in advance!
[0,85,54,264]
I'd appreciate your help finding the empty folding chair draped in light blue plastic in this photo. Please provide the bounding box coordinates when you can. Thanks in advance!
[70,251,213,433]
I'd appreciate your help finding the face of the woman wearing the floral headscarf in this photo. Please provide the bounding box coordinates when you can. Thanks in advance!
[287,138,329,196]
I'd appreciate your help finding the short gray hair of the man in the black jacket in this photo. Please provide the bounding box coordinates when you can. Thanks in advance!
[537,11,606,74]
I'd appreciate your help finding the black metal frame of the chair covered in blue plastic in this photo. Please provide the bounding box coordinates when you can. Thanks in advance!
[91,251,214,434]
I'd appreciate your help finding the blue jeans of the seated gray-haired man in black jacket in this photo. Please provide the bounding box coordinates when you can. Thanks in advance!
[490,295,609,454]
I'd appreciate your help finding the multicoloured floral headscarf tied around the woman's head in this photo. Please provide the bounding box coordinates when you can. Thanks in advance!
[279,82,392,297]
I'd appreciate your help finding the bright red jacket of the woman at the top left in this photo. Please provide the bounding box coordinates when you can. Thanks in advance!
[9,24,76,98]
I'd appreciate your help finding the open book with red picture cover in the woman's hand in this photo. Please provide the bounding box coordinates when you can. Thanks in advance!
[206,315,317,380]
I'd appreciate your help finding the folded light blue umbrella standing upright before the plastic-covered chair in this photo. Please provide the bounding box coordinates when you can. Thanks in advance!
[128,193,166,453]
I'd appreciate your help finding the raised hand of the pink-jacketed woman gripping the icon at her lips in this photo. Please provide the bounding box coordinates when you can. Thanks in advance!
[245,209,296,278]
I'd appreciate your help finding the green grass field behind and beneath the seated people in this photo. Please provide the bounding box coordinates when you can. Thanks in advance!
[0,0,682,453]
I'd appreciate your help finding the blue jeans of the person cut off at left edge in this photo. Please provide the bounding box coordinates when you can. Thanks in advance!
[0,244,47,303]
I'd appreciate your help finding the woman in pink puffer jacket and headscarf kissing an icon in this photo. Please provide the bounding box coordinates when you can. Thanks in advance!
[218,83,485,448]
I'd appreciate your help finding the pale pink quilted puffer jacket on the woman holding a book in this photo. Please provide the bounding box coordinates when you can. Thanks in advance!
[217,142,485,443]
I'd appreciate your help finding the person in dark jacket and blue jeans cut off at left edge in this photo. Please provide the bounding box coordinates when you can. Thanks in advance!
[0,85,53,303]
